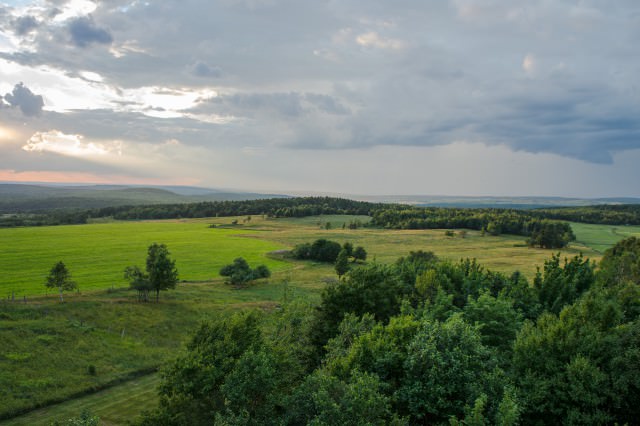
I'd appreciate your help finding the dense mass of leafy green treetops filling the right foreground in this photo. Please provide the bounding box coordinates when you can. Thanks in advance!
[139,238,640,426]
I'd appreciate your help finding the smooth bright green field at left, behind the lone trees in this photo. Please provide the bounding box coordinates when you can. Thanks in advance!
[0,221,287,298]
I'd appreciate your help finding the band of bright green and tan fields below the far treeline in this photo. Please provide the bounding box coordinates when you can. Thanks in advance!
[0,216,624,298]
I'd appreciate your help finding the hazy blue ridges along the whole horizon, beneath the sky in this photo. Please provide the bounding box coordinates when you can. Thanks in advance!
[0,183,640,214]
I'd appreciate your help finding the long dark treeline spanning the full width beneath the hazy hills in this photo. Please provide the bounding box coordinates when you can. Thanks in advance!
[5,197,640,238]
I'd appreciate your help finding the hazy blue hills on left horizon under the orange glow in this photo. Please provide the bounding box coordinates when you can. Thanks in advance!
[0,183,287,214]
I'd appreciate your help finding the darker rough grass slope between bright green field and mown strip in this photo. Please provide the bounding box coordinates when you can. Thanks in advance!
[0,264,334,418]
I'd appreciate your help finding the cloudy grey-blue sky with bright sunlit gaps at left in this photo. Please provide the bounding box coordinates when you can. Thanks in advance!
[0,0,640,197]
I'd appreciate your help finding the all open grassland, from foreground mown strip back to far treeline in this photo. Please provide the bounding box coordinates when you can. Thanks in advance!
[0,216,640,424]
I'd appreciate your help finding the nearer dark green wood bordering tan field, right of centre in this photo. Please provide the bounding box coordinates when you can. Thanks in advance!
[370,206,575,248]
